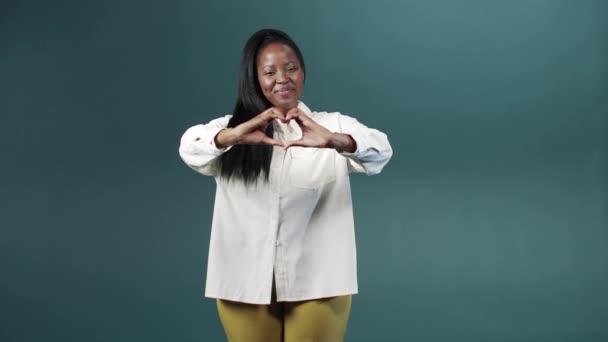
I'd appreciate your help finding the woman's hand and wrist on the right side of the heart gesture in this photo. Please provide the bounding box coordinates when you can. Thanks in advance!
[282,108,357,153]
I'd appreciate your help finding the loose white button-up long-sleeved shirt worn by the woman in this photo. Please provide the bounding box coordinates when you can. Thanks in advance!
[179,102,392,304]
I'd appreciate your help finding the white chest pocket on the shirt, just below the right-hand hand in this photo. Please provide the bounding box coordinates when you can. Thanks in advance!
[287,147,336,190]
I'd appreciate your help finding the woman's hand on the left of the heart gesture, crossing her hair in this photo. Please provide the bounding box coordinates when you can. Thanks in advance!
[215,107,285,148]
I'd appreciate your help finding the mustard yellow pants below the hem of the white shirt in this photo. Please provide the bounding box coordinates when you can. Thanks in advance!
[217,284,352,342]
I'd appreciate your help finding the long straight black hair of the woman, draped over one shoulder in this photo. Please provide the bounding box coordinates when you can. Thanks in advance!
[220,29,306,185]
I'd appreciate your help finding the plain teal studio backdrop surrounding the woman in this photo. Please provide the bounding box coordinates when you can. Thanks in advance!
[0,0,608,342]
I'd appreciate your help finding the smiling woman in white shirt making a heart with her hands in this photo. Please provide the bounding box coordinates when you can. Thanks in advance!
[179,30,392,342]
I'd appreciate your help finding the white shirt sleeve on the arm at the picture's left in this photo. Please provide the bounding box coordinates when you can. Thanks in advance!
[179,115,231,176]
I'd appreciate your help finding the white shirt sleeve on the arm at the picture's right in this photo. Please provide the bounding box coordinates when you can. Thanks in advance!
[339,114,393,175]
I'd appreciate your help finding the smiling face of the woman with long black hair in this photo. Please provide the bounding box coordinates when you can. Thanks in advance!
[257,43,304,111]
